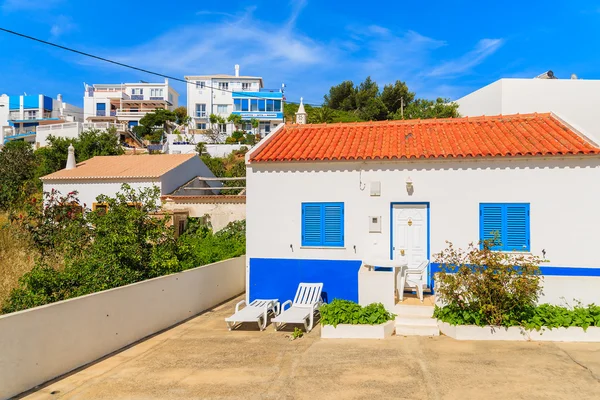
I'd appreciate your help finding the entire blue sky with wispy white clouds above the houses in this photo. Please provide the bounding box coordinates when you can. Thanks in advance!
[0,0,600,105]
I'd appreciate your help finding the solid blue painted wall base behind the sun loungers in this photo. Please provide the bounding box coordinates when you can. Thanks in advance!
[248,258,362,302]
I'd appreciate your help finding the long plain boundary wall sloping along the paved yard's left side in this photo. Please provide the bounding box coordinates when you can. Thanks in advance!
[0,257,246,399]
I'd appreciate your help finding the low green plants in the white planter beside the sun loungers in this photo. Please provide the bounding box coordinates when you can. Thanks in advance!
[320,299,395,327]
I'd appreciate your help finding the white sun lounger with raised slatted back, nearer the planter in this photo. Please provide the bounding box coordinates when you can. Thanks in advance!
[271,283,323,332]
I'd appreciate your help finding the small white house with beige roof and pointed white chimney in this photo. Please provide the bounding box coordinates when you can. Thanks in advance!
[41,152,221,209]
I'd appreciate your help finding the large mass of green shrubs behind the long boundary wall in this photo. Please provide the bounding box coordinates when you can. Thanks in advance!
[1,185,246,313]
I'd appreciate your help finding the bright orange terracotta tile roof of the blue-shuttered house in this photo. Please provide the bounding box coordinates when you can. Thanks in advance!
[250,113,600,162]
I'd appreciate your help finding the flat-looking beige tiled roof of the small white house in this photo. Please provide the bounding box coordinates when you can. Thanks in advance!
[41,154,197,180]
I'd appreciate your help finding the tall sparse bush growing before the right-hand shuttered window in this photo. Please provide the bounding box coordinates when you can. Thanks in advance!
[435,241,544,326]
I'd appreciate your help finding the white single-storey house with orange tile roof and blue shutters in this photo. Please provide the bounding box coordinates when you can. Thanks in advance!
[246,113,600,303]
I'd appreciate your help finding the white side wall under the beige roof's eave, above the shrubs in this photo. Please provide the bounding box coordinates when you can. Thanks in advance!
[43,179,161,210]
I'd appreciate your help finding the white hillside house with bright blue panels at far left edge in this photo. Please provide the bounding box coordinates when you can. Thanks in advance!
[0,94,84,144]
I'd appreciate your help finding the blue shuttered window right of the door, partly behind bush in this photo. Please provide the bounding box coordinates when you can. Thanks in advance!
[479,203,531,251]
